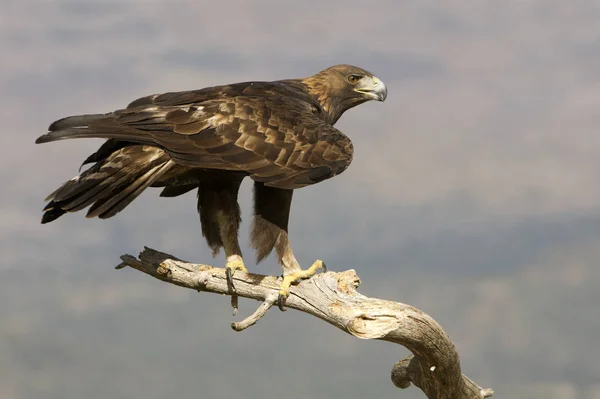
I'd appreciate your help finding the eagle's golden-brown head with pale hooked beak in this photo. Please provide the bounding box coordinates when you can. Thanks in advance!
[303,65,387,124]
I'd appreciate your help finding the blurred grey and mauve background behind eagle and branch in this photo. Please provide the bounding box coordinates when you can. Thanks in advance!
[0,0,600,399]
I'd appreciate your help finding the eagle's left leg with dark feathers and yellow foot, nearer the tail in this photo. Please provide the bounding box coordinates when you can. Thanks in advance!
[198,173,248,292]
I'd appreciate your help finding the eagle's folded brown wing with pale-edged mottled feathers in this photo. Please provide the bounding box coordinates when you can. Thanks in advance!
[38,90,353,189]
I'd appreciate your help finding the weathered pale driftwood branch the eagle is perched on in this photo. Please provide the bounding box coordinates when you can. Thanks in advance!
[117,248,493,399]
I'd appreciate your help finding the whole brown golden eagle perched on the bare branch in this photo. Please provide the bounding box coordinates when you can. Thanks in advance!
[36,65,387,308]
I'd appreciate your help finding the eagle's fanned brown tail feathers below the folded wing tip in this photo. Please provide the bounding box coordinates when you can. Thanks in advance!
[42,145,174,223]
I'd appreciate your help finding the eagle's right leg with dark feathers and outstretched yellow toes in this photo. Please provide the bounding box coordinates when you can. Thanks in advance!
[250,182,325,310]
